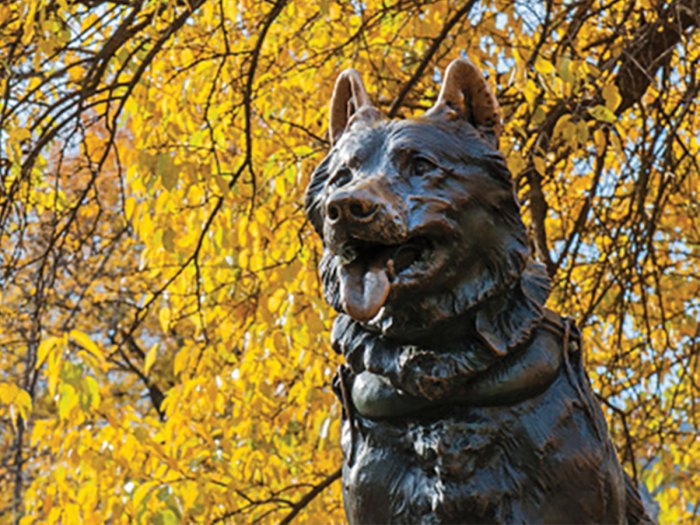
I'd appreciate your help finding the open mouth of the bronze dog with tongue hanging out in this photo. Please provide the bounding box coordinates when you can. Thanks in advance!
[338,237,433,322]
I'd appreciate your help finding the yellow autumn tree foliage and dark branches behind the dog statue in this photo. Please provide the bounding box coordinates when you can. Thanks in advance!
[0,0,700,524]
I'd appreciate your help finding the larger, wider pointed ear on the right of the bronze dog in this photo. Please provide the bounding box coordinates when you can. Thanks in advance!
[426,58,501,147]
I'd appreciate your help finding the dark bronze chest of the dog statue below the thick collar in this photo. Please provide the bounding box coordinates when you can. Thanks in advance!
[343,372,622,524]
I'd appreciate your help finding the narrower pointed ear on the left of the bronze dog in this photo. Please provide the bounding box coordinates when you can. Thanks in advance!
[328,69,378,145]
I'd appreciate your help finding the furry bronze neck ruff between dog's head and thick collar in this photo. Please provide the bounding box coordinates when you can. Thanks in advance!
[332,261,549,377]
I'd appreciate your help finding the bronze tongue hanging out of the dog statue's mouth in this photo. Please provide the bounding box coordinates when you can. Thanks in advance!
[340,258,390,322]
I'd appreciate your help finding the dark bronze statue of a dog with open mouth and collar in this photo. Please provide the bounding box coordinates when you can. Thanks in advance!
[306,59,651,524]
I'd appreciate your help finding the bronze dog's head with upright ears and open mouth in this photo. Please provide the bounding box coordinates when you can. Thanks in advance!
[306,59,548,340]
